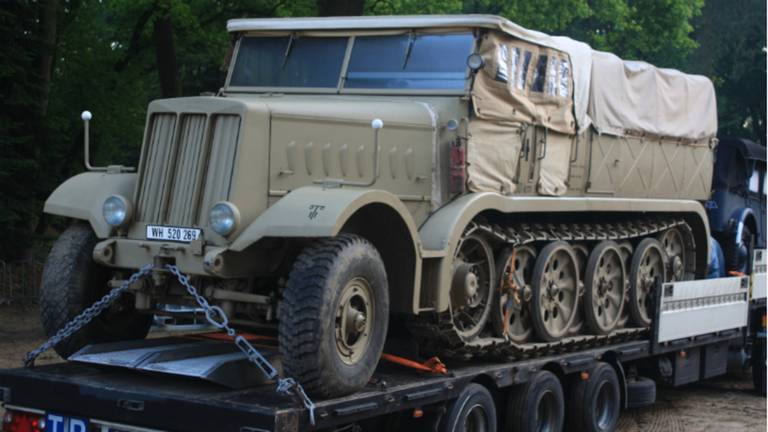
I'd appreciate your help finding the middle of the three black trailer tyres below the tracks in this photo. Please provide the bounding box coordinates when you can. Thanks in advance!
[506,371,565,432]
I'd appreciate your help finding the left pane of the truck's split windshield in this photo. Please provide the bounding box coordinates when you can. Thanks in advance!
[229,36,347,88]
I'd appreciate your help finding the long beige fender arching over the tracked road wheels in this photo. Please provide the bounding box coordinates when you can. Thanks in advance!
[419,192,709,312]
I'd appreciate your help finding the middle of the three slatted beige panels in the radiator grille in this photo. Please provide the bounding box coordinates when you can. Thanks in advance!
[168,114,206,226]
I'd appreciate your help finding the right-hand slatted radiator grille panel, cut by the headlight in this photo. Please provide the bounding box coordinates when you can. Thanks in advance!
[200,115,240,221]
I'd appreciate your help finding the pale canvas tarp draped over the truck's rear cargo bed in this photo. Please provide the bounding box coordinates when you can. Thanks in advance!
[589,51,717,140]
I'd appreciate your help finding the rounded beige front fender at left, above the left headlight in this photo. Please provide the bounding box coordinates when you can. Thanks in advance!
[43,172,137,238]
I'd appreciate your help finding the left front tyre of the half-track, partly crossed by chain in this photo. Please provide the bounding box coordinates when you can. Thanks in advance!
[40,223,152,358]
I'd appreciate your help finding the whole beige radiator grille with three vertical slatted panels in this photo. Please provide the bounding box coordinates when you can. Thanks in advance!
[136,113,240,226]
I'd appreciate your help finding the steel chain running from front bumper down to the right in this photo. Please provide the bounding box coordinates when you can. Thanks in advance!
[165,264,315,426]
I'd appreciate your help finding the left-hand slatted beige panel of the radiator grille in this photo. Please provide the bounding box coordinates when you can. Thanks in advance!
[137,114,176,221]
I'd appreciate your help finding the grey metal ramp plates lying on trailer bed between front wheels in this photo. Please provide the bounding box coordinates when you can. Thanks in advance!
[68,337,282,389]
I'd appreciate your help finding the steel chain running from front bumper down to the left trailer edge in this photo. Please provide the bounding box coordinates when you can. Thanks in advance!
[24,265,152,368]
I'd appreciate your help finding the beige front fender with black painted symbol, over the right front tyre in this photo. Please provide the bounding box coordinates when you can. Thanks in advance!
[228,186,420,252]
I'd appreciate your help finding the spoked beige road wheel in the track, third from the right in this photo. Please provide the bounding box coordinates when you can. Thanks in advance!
[584,241,626,335]
